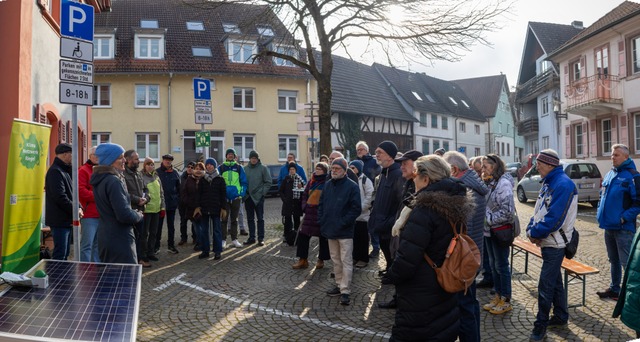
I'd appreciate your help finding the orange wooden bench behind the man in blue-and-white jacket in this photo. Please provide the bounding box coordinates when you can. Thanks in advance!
[511,237,600,308]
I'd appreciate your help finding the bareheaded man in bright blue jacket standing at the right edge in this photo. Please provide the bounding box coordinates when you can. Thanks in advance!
[596,144,640,300]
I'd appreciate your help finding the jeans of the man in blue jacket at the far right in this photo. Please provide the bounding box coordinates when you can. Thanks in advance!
[604,230,634,293]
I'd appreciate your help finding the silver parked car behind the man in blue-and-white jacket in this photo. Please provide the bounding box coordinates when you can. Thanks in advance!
[516,160,602,208]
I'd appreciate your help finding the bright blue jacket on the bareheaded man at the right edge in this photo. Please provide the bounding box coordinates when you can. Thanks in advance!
[596,158,640,233]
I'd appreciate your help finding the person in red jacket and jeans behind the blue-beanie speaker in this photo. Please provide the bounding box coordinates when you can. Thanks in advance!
[78,146,100,262]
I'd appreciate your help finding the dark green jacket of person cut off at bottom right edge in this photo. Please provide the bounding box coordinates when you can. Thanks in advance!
[613,233,640,331]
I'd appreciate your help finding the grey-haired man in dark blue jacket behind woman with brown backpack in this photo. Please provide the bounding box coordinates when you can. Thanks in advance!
[443,151,489,341]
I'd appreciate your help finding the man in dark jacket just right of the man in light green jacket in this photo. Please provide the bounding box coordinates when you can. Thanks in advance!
[155,154,180,254]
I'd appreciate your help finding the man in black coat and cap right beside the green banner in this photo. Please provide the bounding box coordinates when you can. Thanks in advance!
[44,144,82,260]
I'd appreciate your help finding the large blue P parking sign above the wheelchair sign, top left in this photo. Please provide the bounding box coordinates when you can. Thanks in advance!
[60,0,93,41]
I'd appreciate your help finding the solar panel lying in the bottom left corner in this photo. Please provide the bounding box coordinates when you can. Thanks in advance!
[0,260,142,341]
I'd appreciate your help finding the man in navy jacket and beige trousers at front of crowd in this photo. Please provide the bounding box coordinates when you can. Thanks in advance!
[318,158,362,305]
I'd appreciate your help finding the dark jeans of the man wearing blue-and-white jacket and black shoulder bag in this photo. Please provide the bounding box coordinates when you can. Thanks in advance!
[534,247,569,328]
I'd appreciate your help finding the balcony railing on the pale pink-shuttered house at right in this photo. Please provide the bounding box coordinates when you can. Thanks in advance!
[564,75,622,112]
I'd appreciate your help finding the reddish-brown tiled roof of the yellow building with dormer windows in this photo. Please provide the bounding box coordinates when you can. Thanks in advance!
[94,0,308,78]
